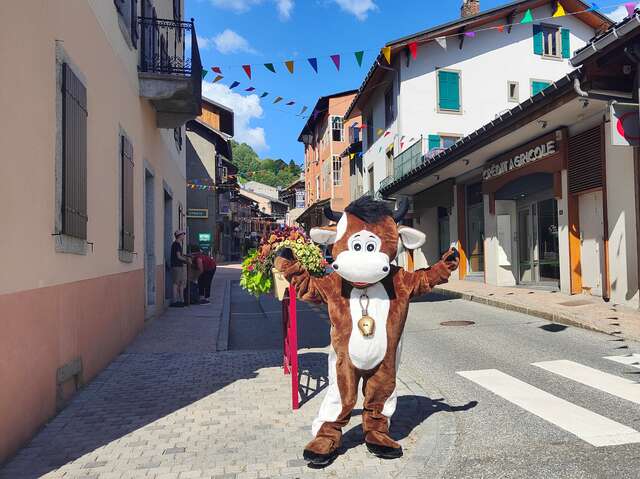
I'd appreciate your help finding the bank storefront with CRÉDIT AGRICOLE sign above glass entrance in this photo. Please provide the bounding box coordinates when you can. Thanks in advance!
[480,129,568,288]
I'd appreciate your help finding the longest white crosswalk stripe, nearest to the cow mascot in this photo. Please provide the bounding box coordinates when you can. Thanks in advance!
[457,369,640,447]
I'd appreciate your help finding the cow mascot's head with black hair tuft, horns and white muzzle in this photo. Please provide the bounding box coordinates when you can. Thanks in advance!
[311,196,425,287]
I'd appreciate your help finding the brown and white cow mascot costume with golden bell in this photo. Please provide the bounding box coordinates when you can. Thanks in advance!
[275,196,459,466]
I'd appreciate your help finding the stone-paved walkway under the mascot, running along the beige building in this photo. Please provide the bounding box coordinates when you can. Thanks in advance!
[0,266,453,479]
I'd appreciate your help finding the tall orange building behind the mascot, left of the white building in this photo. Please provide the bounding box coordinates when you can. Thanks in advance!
[298,90,360,228]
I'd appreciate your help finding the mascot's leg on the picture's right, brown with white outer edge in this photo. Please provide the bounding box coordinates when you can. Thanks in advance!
[362,345,402,459]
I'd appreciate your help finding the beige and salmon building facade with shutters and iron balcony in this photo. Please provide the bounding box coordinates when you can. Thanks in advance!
[0,0,201,462]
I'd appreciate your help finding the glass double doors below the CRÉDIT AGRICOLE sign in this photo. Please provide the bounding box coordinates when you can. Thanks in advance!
[517,198,560,286]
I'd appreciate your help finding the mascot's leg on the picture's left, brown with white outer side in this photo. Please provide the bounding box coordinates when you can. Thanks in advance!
[303,348,359,466]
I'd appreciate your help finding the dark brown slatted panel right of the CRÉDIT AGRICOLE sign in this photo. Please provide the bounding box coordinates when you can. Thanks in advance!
[568,125,604,194]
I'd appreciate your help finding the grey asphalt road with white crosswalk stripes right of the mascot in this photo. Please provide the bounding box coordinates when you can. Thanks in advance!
[401,296,640,479]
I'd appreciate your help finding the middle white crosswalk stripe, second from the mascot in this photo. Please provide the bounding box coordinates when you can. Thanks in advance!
[533,360,640,404]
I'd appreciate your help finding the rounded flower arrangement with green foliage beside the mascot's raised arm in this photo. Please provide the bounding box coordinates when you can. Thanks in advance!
[240,226,327,300]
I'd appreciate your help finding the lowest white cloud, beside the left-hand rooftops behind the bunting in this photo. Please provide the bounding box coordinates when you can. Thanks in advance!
[202,81,269,151]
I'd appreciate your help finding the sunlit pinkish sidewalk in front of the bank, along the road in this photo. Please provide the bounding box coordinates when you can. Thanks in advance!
[434,280,640,341]
